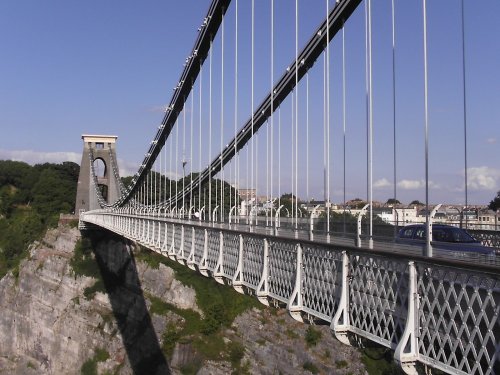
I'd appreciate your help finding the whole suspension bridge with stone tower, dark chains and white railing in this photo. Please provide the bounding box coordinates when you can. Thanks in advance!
[76,0,500,375]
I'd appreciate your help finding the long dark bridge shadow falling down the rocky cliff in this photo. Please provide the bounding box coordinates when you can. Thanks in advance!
[86,231,170,374]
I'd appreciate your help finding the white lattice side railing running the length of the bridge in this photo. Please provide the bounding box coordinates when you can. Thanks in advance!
[80,209,500,375]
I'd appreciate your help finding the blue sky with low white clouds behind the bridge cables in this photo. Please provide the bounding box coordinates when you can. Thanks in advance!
[0,0,500,204]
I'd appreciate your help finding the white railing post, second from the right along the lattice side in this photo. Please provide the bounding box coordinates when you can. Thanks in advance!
[330,251,351,345]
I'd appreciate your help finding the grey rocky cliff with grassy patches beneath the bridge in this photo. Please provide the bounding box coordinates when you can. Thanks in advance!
[0,226,365,374]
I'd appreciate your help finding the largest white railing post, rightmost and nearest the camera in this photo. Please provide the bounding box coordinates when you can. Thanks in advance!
[394,262,419,375]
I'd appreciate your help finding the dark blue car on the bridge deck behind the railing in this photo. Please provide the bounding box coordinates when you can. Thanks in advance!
[396,224,496,255]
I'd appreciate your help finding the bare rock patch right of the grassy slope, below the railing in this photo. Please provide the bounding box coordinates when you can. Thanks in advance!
[229,309,365,375]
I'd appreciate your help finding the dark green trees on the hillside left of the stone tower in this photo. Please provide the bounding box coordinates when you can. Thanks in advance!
[0,160,80,278]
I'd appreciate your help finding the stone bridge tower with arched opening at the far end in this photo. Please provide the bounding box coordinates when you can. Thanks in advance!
[75,134,120,214]
